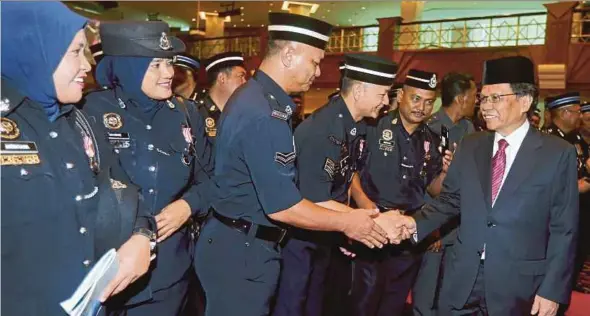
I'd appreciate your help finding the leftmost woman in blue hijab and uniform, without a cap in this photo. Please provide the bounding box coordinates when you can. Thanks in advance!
[0,2,155,316]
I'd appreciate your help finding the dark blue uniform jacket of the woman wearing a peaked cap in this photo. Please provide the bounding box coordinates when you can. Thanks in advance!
[84,88,212,290]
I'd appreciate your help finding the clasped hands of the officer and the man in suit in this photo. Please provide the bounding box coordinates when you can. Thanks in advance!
[341,209,416,256]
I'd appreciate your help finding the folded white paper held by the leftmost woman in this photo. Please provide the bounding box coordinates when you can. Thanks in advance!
[60,249,119,316]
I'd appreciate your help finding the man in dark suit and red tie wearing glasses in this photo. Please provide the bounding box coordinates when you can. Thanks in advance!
[398,57,578,316]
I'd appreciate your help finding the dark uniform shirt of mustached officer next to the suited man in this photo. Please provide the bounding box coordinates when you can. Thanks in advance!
[361,111,442,211]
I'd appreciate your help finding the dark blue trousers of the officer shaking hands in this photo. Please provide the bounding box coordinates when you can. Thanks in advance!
[195,217,281,316]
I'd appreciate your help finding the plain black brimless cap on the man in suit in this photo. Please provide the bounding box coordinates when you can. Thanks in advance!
[483,56,535,85]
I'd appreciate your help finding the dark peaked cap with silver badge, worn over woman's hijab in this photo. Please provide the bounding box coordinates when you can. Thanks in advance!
[100,21,186,58]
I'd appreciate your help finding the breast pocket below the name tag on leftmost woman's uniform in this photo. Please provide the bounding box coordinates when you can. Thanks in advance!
[2,165,63,227]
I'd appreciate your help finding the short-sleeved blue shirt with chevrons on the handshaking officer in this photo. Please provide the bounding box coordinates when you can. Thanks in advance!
[213,71,302,226]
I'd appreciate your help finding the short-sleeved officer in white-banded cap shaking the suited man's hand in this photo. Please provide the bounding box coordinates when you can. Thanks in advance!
[195,13,386,316]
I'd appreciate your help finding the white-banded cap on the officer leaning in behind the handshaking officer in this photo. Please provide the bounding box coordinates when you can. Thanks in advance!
[344,54,397,86]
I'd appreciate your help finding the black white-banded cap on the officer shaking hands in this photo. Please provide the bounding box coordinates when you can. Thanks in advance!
[268,12,332,49]
